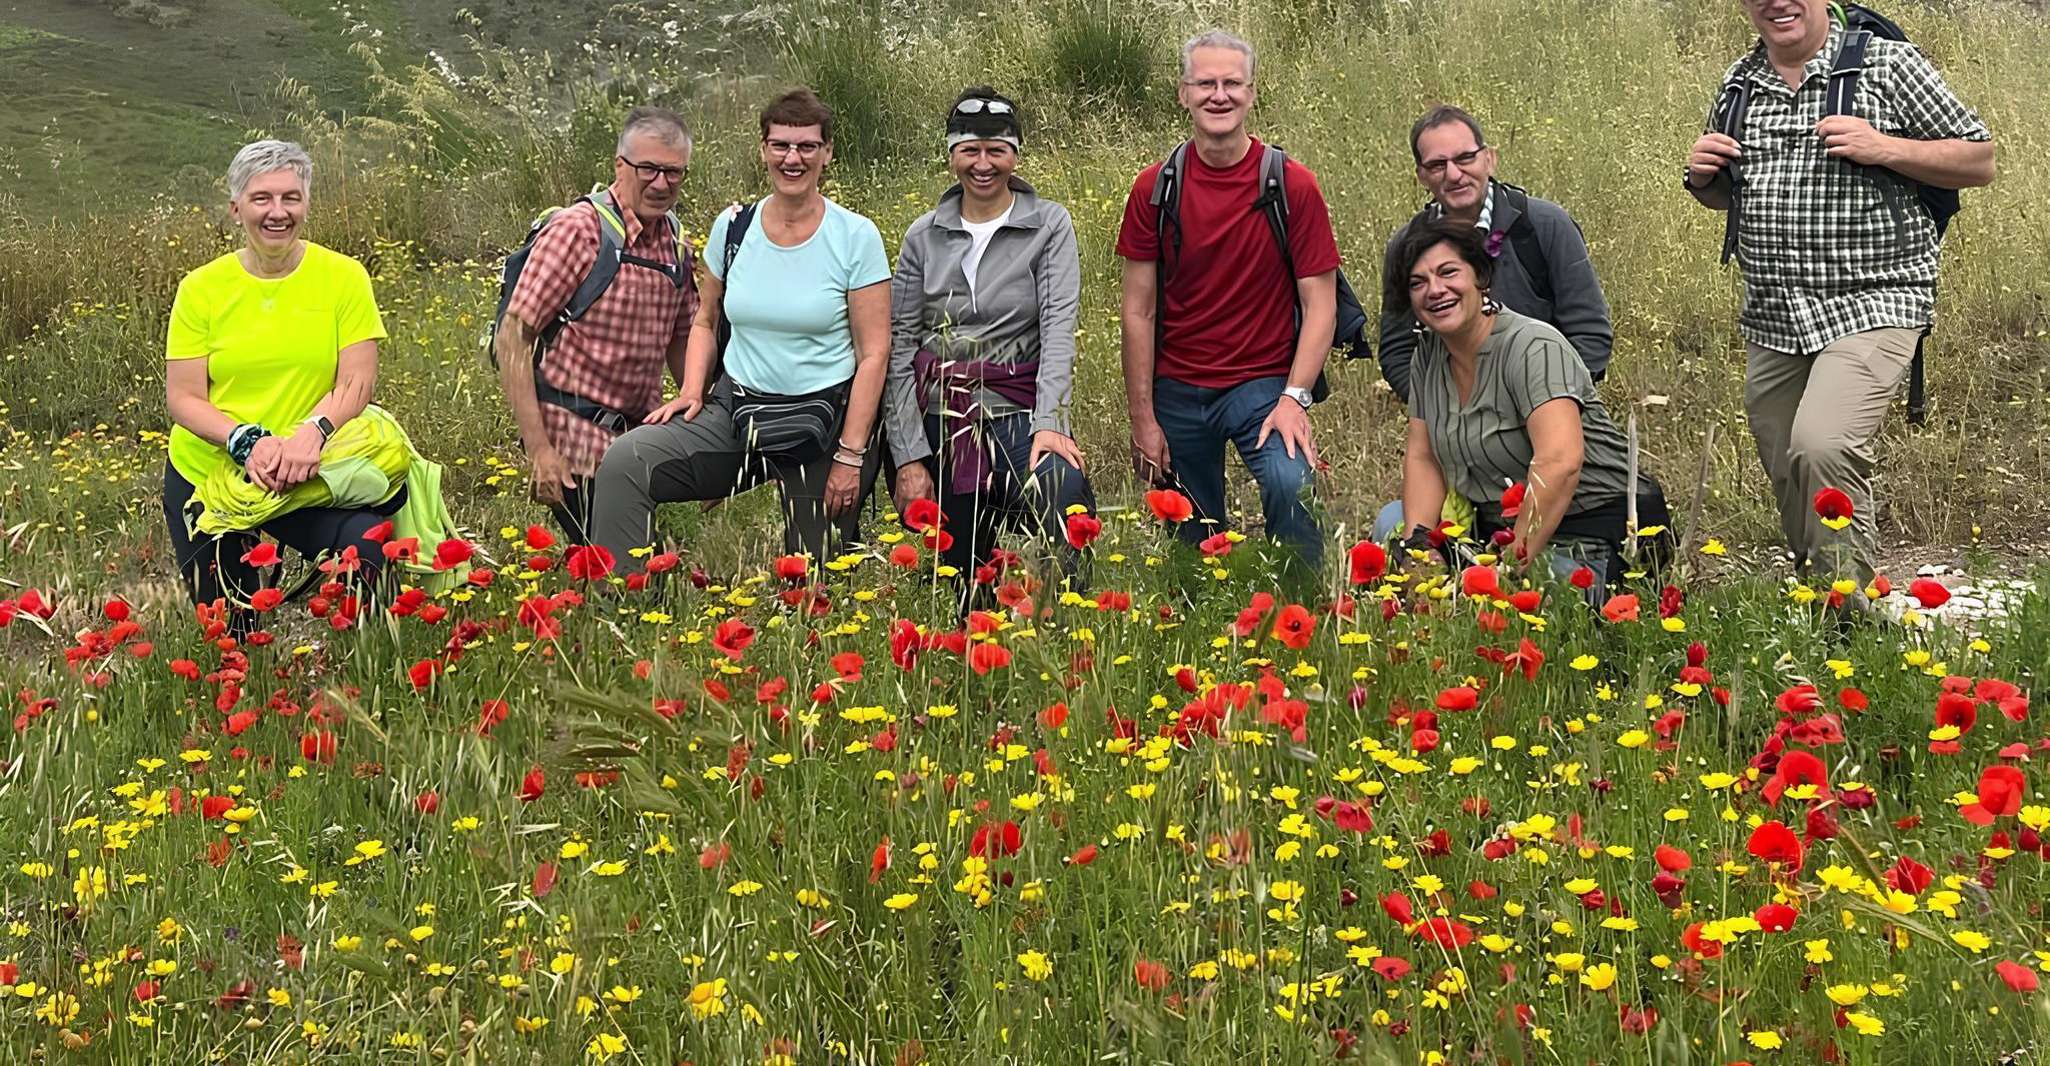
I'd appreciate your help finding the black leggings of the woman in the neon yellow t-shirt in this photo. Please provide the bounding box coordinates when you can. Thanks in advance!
[164,463,403,607]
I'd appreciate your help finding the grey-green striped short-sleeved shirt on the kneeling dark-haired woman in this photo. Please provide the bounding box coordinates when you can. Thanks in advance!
[1410,310,1630,515]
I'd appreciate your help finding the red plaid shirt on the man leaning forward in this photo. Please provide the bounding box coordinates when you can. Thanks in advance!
[508,191,697,478]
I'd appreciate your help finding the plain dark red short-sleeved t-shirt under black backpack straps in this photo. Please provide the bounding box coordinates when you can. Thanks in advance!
[1117,139,1339,387]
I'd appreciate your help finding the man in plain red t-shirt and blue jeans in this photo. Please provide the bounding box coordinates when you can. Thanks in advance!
[1117,31,1339,568]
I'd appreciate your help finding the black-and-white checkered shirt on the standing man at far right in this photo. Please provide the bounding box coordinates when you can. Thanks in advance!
[1710,25,1993,355]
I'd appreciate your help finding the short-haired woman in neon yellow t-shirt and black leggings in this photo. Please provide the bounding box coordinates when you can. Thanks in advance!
[164,141,406,615]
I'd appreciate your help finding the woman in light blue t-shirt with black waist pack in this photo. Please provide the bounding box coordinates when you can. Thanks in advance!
[592,90,890,574]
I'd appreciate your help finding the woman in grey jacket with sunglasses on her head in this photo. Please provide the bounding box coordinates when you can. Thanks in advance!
[886,86,1091,594]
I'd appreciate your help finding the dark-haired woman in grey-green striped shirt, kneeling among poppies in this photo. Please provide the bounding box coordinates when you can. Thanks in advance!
[1386,221,1667,584]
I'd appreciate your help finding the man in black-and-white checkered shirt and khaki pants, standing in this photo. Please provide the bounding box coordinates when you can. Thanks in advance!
[1685,0,1993,582]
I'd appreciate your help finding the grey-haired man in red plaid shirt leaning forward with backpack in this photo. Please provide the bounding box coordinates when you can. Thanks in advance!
[494,107,697,543]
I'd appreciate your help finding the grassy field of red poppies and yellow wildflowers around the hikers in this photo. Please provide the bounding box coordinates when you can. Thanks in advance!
[0,0,2050,1066]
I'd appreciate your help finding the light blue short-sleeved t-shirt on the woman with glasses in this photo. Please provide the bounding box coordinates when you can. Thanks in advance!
[705,199,890,396]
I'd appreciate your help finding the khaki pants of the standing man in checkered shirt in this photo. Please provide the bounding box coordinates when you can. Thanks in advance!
[1745,328,1921,580]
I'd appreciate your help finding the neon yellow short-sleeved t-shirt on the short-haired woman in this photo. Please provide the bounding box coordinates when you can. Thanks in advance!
[164,242,385,486]
